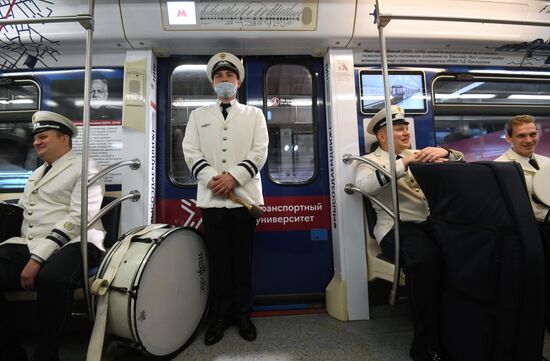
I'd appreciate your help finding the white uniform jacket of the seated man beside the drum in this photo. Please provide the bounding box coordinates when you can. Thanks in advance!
[2,151,105,262]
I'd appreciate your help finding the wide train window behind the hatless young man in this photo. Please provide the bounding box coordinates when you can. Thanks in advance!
[432,74,550,161]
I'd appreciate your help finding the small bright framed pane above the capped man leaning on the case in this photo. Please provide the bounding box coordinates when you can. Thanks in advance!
[359,70,427,114]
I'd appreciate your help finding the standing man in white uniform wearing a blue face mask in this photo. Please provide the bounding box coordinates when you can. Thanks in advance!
[183,52,269,345]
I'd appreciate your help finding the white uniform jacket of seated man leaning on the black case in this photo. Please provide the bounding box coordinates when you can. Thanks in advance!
[355,147,464,242]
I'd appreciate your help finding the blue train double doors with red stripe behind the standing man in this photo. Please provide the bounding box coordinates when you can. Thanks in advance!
[156,57,333,304]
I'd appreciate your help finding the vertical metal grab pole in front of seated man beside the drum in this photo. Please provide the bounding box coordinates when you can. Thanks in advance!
[80,0,95,321]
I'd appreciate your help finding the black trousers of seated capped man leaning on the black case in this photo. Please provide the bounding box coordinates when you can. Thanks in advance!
[380,222,443,353]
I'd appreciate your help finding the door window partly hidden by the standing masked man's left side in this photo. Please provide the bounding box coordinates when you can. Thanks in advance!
[170,64,216,185]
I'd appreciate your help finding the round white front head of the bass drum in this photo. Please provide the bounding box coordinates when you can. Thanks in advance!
[132,228,208,356]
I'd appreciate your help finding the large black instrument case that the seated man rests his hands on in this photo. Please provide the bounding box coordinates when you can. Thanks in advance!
[410,162,547,361]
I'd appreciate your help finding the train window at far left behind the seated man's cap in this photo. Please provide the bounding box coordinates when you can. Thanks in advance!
[0,78,40,192]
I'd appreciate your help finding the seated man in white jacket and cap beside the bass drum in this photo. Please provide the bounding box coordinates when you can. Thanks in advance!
[0,111,105,361]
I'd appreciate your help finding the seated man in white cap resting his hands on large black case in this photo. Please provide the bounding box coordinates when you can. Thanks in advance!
[356,105,463,361]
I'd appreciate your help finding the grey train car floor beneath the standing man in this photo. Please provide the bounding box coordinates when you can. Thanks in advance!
[10,283,550,361]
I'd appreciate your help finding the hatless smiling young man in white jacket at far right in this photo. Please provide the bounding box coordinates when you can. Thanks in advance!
[495,115,550,223]
